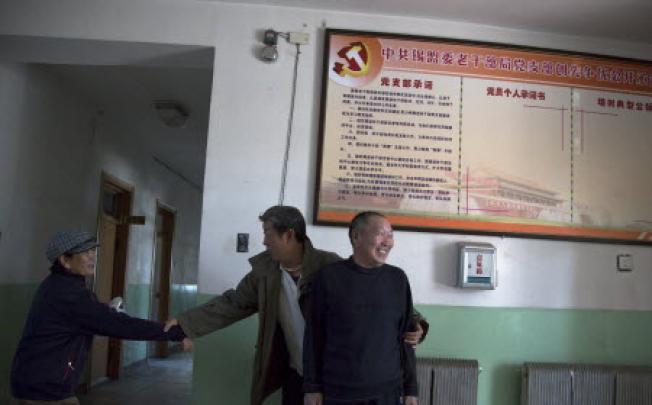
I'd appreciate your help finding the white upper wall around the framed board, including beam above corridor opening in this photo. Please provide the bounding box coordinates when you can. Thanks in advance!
[0,0,652,310]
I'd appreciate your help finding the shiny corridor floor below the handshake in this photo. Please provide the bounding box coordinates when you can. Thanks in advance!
[78,353,192,405]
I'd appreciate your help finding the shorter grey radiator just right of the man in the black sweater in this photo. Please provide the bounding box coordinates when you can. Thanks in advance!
[417,358,479,405]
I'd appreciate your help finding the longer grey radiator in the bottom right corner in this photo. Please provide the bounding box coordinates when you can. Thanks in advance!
[521,363,652,405]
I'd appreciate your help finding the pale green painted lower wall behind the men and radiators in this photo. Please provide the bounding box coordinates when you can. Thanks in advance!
[188,295,652,405]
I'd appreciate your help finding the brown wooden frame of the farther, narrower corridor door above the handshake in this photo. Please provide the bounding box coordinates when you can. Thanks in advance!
[150,199,177,358]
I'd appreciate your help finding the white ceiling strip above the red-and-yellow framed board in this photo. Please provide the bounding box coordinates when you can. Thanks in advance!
[222,0,652,44]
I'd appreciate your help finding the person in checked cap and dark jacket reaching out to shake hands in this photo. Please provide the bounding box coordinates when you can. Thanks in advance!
[10,231,185,405]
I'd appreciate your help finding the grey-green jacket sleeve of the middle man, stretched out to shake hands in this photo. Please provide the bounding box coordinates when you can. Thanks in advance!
[177,272,260,338]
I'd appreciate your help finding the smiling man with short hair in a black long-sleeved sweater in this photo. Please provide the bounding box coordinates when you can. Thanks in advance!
[303,211,417,405]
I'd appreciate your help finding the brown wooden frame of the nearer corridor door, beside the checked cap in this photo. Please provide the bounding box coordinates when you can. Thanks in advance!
[98,171,134,380]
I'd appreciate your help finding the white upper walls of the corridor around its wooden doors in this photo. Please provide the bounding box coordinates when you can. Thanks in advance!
[0,63,201,284]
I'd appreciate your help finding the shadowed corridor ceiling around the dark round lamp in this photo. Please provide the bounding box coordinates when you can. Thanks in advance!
[48,63,213,189]
